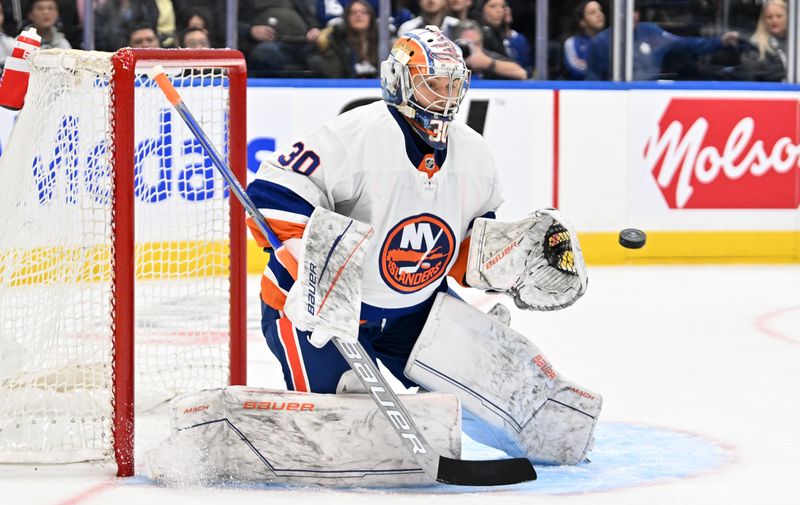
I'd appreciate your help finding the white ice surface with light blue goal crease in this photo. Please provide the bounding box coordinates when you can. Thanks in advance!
[0,265,800,505]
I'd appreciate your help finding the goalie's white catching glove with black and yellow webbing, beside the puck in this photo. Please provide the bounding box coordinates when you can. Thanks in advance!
[466,208,588,310]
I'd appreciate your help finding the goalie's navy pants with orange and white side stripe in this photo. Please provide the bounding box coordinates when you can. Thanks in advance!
[261,300,433,393]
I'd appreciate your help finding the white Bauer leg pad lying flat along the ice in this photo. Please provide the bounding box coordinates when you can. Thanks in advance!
[145,387,461,487]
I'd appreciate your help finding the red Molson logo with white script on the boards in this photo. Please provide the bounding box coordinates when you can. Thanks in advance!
[643,98,800,209]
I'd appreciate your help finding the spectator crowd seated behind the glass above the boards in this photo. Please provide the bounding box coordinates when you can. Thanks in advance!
[0,0,788,81]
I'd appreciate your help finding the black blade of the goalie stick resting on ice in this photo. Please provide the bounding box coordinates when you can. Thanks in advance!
[436,456,536,486]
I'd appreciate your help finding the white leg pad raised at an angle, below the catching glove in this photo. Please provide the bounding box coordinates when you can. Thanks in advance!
[405,293,603,465]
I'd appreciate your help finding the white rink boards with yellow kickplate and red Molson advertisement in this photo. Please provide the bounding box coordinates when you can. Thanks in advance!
[0,80,800,266]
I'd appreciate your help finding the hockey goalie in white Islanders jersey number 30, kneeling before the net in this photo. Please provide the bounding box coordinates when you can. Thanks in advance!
[151,26,602,486]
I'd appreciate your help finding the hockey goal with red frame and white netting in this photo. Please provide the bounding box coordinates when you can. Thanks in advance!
[0,48,247,476]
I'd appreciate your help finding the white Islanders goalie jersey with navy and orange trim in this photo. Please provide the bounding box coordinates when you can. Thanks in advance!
[247,101,502,320]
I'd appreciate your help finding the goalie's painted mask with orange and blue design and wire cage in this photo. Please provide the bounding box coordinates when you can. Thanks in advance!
[381,26,471,149]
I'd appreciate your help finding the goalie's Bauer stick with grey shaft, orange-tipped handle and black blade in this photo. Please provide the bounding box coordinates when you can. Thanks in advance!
[148,65,536,486]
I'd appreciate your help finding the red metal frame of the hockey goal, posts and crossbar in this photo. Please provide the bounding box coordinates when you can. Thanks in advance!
[112,49,247,476]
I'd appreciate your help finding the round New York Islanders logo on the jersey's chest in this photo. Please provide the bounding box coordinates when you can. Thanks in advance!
[378,214,455,293]
